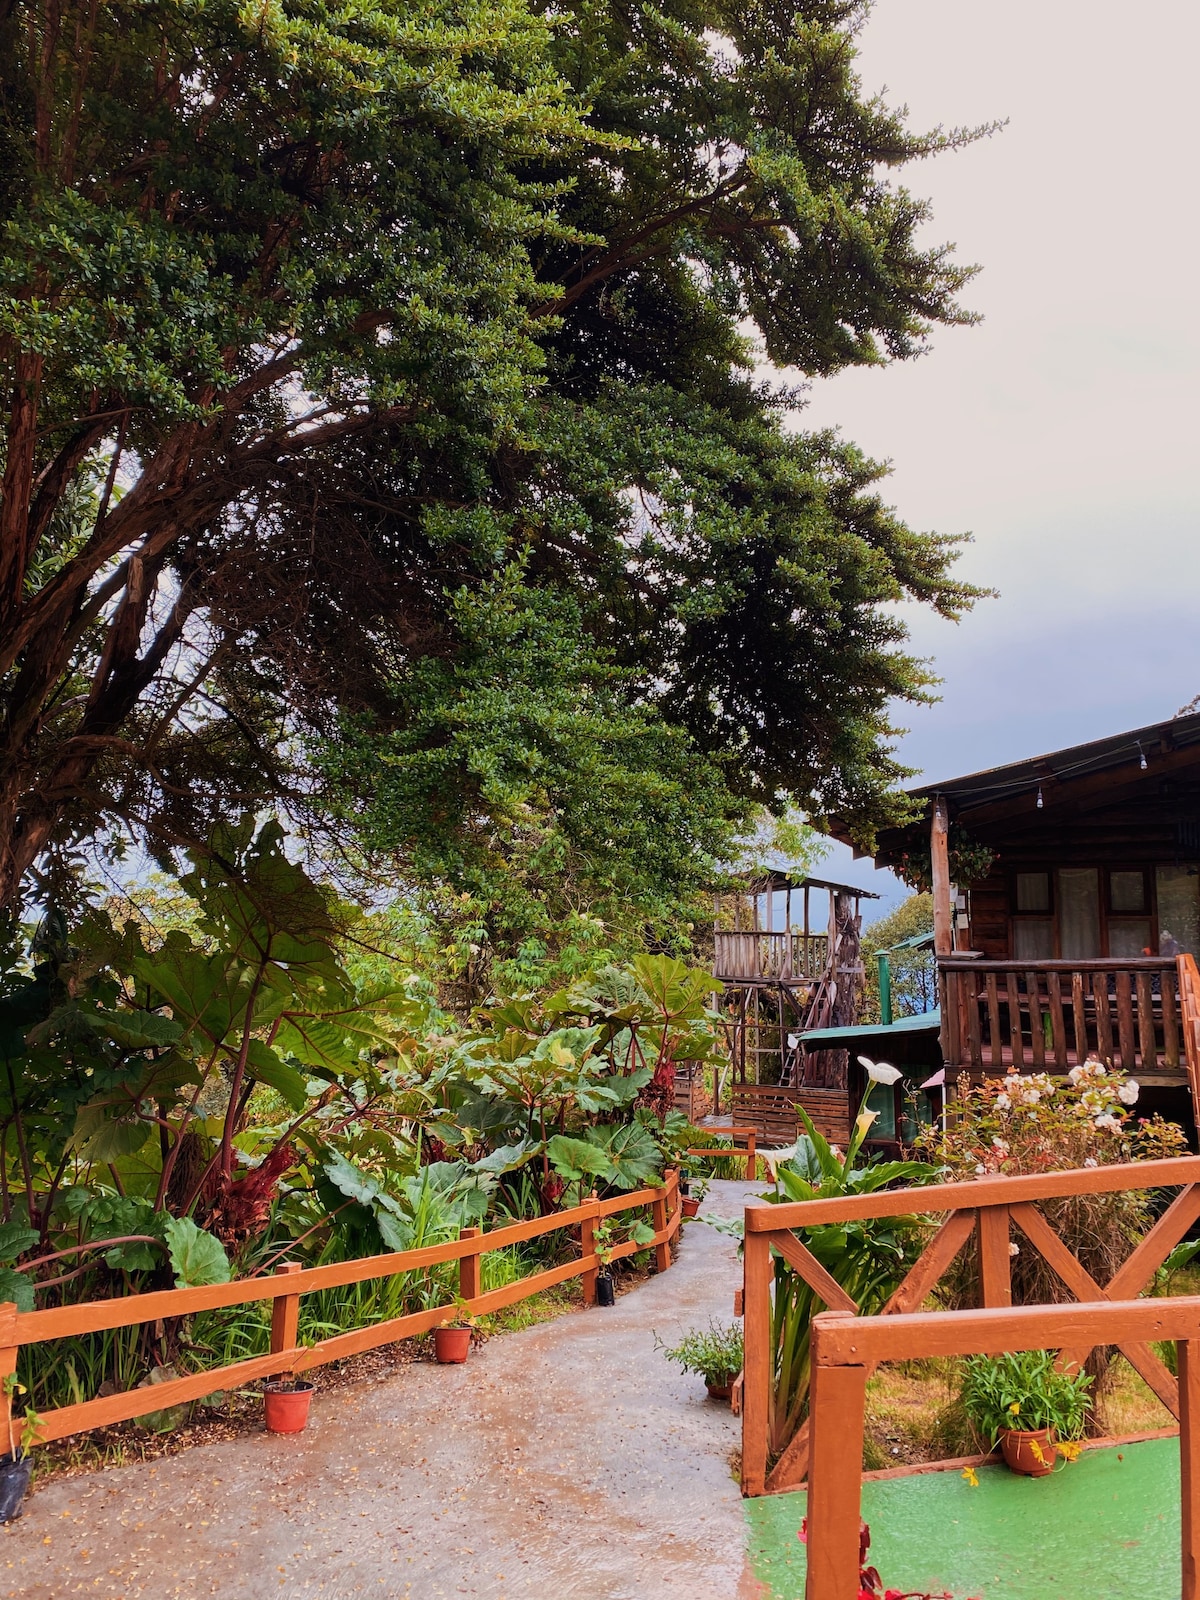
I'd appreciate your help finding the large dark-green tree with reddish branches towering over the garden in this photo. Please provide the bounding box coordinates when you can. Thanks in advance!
[0,0,970,904]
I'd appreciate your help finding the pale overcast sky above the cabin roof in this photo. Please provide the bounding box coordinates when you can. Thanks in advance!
[808,0,1200,915]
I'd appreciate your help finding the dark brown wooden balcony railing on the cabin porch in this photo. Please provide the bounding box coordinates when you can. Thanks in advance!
[938,957,1195,1075]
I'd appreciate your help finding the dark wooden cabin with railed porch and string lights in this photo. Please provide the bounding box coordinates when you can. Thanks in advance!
[835,714,1200,1122]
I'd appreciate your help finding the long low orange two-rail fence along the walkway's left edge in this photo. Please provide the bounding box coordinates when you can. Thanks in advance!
[0,1173,680,1442]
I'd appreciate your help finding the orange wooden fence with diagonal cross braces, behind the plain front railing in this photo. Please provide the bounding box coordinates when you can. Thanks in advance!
[742,1155,1200,1491]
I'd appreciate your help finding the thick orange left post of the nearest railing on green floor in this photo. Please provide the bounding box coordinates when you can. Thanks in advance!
[805,1312,867,1600]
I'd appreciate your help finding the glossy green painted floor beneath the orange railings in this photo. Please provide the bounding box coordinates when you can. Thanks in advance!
[744,1438,1179,1600]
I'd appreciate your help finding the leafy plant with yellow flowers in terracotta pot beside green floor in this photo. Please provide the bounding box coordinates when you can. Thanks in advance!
[962,1350,1091,1478]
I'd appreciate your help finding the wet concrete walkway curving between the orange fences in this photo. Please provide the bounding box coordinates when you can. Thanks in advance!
[0,1182,757,1600]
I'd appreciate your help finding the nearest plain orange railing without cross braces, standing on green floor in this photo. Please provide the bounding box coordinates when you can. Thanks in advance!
[803,1299,1200,1600]
